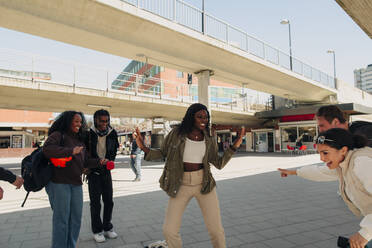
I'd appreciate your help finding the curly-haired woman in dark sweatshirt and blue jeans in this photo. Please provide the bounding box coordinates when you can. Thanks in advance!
[42,111,102,248]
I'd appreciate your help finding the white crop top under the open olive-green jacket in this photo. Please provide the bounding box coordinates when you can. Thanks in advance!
[183,137,206,164]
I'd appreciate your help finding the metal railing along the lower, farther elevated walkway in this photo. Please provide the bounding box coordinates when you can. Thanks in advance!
[0,49,268,112]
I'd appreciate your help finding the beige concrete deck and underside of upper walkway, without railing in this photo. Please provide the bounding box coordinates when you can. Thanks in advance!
[0,0,336,102]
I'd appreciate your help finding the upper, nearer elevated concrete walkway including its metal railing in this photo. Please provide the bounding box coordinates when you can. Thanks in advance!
[0,0,336,102]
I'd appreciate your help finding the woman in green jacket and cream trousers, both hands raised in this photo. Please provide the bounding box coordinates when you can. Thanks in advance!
[136,103,245,248]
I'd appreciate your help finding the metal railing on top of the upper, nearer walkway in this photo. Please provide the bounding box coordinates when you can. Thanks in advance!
[121,0,336,88]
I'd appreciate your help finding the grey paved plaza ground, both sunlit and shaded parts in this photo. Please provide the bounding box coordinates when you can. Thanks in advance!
[0,153,360,248]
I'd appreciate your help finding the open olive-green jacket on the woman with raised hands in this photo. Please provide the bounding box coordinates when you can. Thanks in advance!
[145,127,234,197]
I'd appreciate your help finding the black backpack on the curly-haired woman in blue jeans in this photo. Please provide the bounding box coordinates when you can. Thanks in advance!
[21,135,64,207]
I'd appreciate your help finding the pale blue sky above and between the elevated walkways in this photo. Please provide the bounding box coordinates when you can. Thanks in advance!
[0,0,372,84]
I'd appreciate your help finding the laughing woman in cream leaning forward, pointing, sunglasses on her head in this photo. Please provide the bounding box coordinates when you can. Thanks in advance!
[278,128,372,248]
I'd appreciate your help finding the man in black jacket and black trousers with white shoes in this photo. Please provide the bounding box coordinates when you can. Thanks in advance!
[86,109,119,243]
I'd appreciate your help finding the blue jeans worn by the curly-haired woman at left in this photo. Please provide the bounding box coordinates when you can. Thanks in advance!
[45,182,83,248]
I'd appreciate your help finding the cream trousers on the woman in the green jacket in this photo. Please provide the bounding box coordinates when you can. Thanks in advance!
[163,170,226,248]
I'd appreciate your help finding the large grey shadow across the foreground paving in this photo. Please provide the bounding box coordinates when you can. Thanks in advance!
[0,168,359,248]
